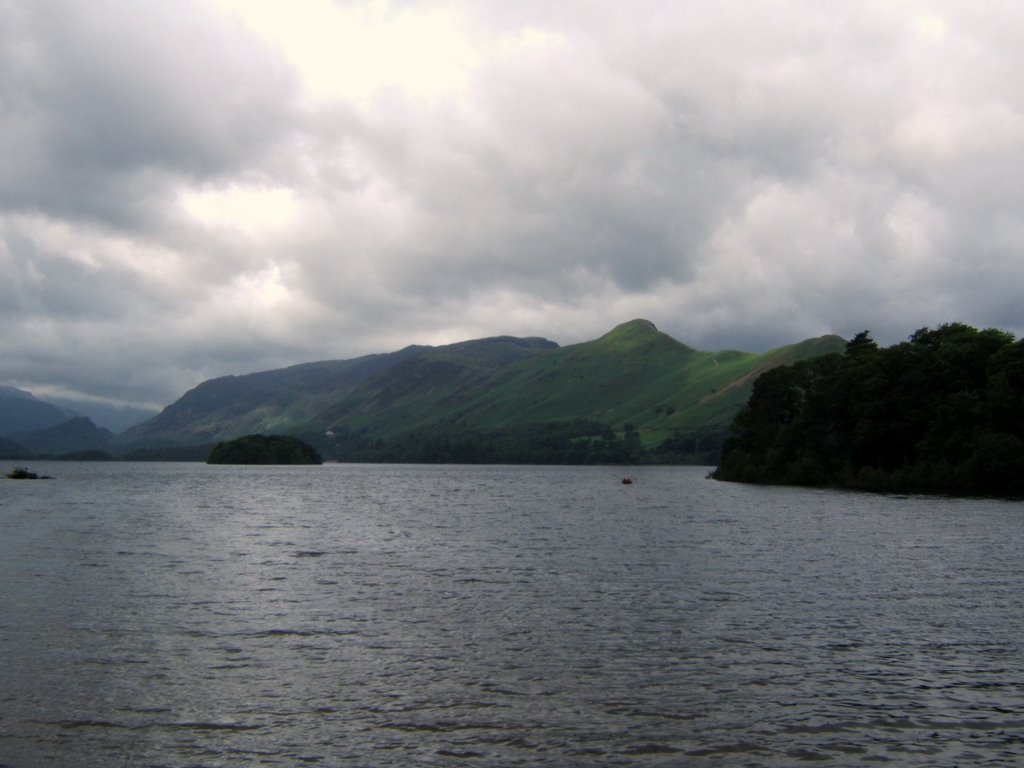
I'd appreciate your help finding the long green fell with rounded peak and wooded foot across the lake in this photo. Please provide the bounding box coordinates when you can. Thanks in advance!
[120,319,844,461]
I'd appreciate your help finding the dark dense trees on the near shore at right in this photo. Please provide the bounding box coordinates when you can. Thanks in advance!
[714,323,1024,497]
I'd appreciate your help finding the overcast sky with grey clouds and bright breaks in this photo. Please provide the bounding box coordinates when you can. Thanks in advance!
[0,0,1024,417]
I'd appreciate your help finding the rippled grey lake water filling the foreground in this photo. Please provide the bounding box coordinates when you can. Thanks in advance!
[0,463,1024,768]
